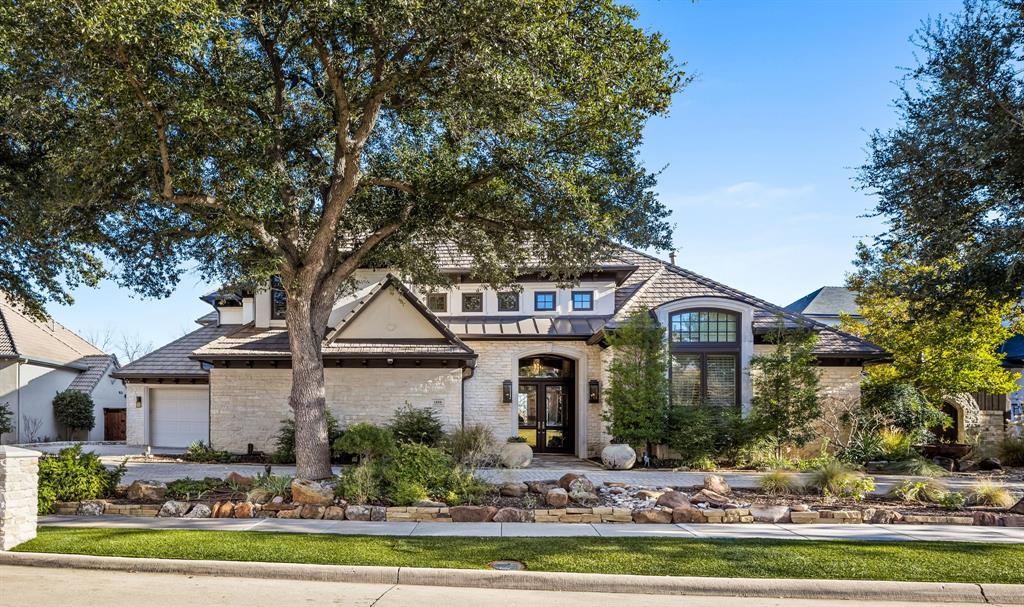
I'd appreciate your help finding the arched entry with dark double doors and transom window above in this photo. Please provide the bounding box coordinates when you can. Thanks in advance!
[516,354,575,453]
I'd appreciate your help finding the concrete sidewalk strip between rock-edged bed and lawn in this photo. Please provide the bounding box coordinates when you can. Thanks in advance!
[39,516,1024,544]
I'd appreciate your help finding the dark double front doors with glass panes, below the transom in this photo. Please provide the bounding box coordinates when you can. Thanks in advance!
[519,379,573,453]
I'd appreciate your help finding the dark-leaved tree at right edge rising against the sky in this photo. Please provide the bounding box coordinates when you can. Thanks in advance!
[859,0,1024,314]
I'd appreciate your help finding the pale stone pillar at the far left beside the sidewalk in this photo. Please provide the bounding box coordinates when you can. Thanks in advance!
[0,445,42,550]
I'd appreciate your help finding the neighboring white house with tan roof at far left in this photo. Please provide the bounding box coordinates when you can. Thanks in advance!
[0,294,126,443]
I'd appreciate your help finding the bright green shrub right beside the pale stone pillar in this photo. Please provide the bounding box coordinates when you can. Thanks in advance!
[39,445,127,514]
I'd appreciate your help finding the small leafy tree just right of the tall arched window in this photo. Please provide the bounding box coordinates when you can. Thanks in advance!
[751,327,821,457]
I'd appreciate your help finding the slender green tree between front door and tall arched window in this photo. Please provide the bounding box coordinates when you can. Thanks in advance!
[604,310,669,452]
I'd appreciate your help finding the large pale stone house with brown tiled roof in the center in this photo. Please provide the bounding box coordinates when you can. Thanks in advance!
[110,248,884,457]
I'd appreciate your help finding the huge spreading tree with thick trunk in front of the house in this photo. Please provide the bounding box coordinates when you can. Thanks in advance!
[0,0,685,478]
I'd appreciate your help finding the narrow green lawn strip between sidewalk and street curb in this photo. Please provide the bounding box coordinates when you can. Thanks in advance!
[15,527,1024,583]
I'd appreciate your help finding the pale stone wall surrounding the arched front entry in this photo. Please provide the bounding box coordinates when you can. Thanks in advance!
[466,340,607,457]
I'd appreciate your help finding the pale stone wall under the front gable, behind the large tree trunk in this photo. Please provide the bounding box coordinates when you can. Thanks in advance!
[210,368,462,452]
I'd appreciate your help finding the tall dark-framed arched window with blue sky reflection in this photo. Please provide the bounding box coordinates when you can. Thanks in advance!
[669,310,739,406]
